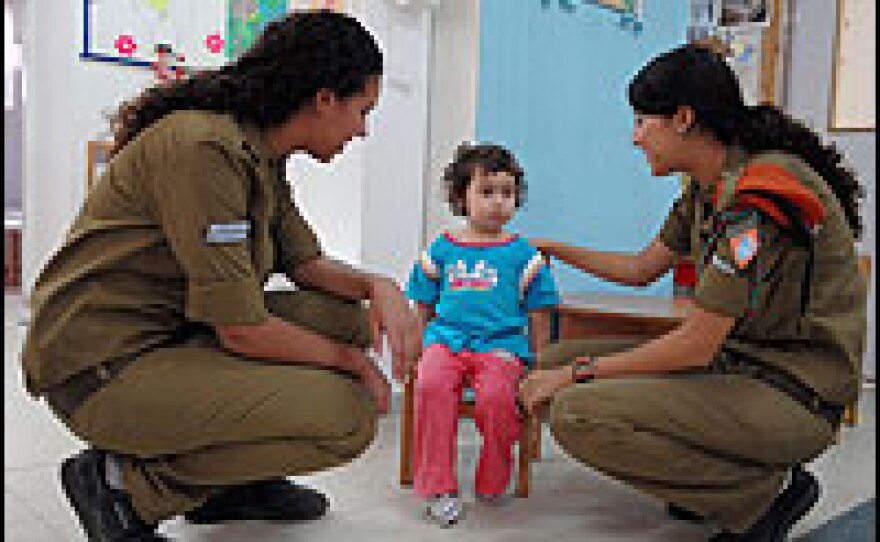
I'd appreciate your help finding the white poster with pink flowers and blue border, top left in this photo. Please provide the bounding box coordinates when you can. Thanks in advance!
[80,0,227,69]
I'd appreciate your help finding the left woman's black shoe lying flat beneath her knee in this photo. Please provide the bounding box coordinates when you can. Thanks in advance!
[184,479,329,524]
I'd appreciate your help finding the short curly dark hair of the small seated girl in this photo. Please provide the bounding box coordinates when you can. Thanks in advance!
[443,143,526,216]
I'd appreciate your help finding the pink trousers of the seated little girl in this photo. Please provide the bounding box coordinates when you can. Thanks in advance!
[413,345,523,497]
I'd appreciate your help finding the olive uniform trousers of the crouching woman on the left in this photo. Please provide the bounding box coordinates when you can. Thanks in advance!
[49,291,378,522]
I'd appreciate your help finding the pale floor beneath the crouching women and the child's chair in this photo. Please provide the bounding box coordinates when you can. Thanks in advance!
[4,296,876,542]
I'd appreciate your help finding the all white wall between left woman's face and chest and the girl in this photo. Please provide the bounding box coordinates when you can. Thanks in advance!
[288,0,431,281]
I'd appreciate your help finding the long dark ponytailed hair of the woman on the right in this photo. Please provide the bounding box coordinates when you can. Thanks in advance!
[628,44,864,239]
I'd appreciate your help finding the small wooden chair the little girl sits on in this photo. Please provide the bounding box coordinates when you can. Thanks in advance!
[400,368,541,497]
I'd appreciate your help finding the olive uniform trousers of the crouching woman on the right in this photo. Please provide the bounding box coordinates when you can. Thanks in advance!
[538,339,836,532]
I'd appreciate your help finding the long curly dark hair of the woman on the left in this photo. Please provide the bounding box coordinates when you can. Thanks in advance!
[111,10,383,159]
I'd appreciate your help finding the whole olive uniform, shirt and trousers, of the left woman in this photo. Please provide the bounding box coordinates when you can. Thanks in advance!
[23,111,377,522]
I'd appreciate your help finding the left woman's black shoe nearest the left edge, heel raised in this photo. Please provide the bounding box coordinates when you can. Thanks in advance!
[61,450,168,542]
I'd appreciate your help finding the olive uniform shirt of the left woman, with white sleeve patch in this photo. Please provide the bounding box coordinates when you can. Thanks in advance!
[23,111,321,393]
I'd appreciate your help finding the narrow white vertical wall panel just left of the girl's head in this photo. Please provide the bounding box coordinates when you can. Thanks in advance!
[361,4,431,282]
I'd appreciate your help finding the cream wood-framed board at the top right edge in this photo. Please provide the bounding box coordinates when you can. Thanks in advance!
[828,0,877,132]
